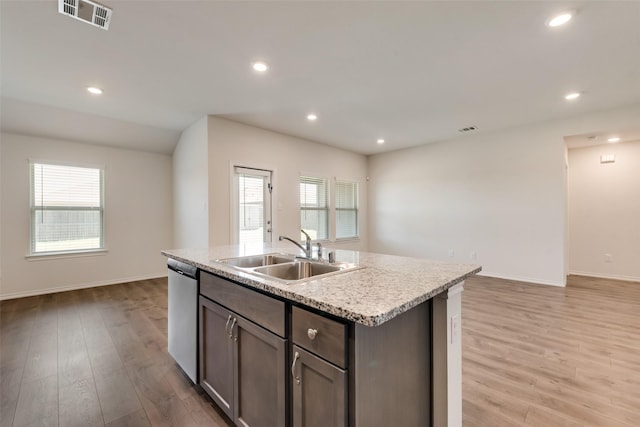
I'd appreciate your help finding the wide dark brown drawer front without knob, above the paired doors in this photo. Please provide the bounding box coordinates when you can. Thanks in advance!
[200,271,285,337]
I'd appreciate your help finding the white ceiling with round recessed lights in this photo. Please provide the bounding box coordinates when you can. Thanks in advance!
[0,0,640,154]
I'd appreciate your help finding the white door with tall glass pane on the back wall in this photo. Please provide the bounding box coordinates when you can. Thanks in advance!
[232,166,273,245]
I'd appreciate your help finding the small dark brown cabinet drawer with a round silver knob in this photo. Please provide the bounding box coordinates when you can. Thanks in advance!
[291,307,347,368]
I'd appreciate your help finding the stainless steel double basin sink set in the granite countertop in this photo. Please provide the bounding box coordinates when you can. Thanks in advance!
[216,253,360,284]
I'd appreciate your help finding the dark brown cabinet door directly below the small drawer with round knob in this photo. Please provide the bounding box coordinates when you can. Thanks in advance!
[291,345,348,427]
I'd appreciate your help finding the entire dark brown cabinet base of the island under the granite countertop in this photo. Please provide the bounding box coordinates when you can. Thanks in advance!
[199,271,432,427]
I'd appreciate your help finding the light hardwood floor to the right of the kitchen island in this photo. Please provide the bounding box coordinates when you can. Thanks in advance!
[462,276,640,427]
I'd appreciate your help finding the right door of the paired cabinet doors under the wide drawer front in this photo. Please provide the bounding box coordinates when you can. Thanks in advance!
[233,315,287,427]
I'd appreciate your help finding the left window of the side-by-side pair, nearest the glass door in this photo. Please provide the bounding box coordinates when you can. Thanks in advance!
[300,176,329,240]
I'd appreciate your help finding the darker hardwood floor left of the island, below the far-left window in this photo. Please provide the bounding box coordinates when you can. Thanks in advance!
[0,279,231,427]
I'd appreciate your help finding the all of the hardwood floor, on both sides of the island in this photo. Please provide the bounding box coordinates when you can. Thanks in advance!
[0,277,640,427]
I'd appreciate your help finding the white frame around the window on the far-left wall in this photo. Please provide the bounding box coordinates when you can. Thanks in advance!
[26,159,107,259]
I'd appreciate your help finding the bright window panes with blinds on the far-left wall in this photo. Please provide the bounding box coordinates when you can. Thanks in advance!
[30,162,104,255]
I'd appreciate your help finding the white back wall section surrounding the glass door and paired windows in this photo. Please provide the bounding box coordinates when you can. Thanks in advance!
[208,116,368,250]
